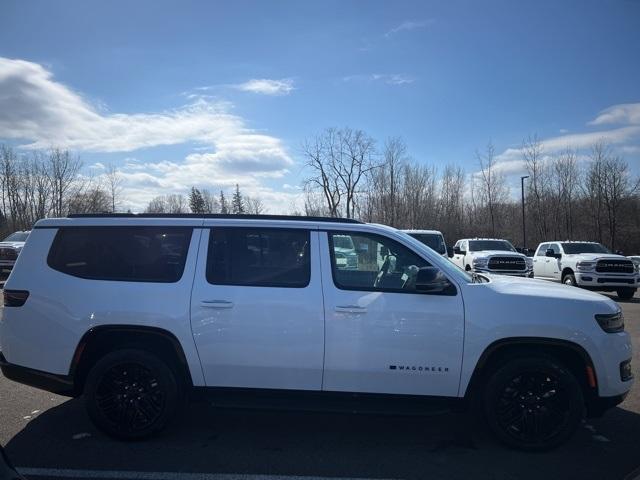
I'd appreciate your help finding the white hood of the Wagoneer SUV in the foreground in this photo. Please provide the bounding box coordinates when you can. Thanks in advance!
[483,274,619,313]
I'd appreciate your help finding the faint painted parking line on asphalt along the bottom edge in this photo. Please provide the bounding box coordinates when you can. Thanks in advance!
[17,467,392,480]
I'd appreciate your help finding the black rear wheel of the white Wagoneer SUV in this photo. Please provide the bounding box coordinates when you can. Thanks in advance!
[84,349,183,440]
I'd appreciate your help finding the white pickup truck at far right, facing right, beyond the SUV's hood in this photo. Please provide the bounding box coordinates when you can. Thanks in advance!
[533,241,640,299]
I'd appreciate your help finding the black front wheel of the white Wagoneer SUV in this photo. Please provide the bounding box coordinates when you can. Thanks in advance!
[483,356,585,451]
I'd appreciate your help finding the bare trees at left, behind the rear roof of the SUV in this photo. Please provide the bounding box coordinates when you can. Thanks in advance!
[0,145,266,239]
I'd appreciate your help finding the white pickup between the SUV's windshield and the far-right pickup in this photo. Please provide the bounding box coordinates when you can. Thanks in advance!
[451,238,533,277]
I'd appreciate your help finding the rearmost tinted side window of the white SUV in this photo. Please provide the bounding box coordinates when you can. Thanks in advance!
[48,227,192,283]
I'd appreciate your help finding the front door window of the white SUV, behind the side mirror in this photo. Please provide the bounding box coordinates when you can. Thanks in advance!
[329,232,429,292]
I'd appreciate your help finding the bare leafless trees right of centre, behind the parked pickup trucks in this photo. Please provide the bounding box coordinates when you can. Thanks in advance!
[303,128,640,254]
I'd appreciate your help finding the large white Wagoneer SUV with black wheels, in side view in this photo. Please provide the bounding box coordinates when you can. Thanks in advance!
[0,215,632,450]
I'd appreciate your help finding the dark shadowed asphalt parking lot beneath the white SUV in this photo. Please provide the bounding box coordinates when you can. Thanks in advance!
[0,295,640,480]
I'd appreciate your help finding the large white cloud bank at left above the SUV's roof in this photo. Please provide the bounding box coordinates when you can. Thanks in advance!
[0,57,297,211]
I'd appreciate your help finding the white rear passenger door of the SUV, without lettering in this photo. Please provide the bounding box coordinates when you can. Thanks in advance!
[191,228,324,390]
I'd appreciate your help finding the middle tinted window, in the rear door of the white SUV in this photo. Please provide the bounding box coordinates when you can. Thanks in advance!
[207,228,311,288]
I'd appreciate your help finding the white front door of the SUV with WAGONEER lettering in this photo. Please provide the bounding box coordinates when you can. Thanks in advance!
[320,232,464,396]
